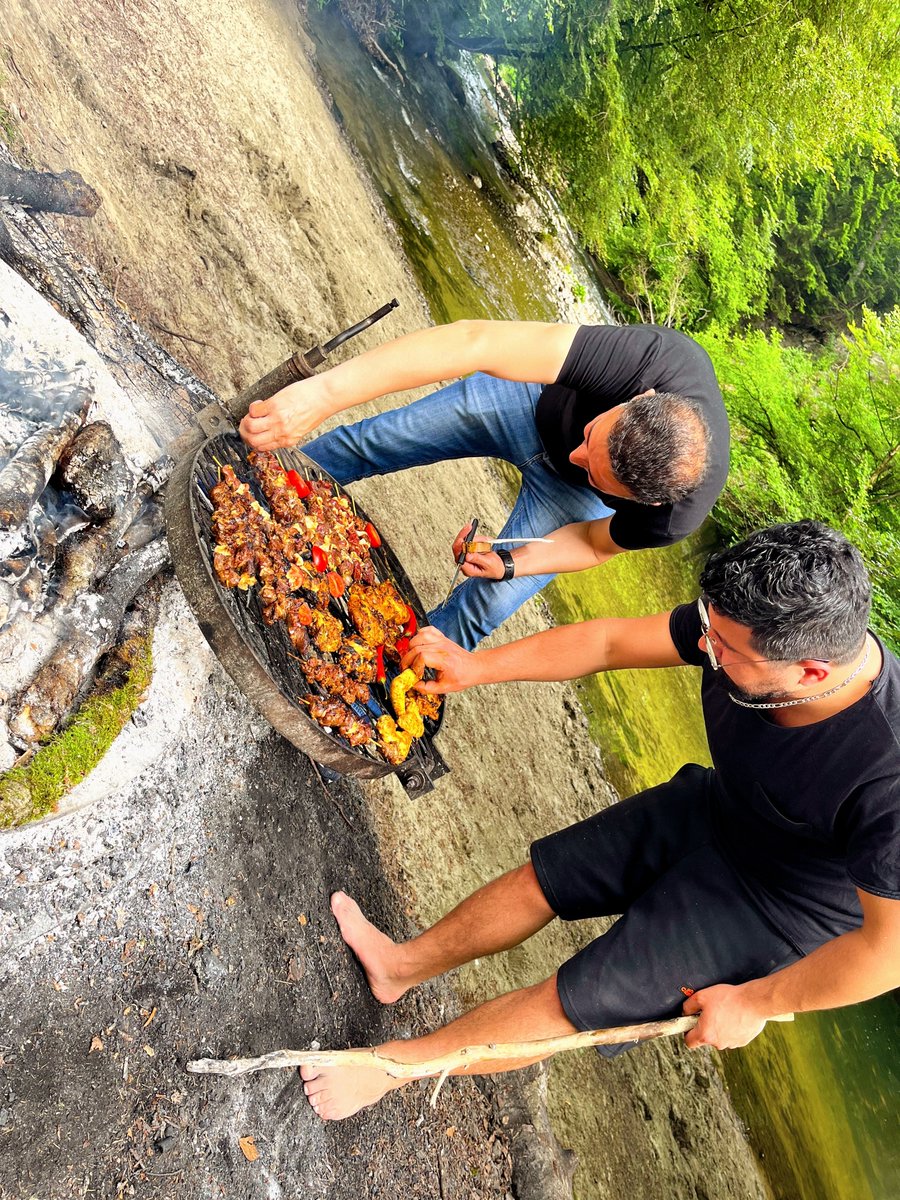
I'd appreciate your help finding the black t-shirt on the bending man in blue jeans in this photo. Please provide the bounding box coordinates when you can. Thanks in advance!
[535,325,728,550]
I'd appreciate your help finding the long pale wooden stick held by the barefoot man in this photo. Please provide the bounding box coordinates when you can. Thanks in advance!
[187,1015,793,1079]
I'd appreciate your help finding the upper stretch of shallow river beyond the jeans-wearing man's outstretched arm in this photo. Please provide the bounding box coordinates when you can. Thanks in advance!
[310,7,611,322]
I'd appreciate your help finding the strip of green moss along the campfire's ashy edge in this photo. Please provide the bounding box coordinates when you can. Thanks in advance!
[0,631,152,829]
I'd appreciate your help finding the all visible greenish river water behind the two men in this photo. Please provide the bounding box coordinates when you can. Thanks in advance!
[310,6,900,1200]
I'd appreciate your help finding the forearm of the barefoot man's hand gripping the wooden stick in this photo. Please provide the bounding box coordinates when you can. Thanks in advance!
[740,929,900,1019]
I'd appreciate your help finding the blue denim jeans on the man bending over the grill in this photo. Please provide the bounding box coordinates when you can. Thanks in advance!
[304,374,612,650]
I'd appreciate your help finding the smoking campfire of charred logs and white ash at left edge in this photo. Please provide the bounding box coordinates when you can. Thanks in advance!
[0,341,170,787]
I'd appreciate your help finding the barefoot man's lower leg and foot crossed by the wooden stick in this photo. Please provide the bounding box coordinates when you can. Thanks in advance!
[300,969,575,1121]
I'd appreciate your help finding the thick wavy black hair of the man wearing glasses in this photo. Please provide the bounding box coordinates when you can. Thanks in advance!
[700,521,871,664]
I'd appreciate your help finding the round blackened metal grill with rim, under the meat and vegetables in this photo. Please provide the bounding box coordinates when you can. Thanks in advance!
[167,432,448,794]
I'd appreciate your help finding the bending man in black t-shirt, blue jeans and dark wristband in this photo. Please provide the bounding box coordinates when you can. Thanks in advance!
[241,320,728,649]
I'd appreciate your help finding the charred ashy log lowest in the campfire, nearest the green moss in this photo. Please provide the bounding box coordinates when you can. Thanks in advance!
[10,538,169,746]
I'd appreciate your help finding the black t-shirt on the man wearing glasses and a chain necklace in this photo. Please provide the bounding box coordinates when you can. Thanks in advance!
[670,605,900,952]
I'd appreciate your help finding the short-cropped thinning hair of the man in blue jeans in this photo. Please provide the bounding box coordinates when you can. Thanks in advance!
[607,391,709,504]
